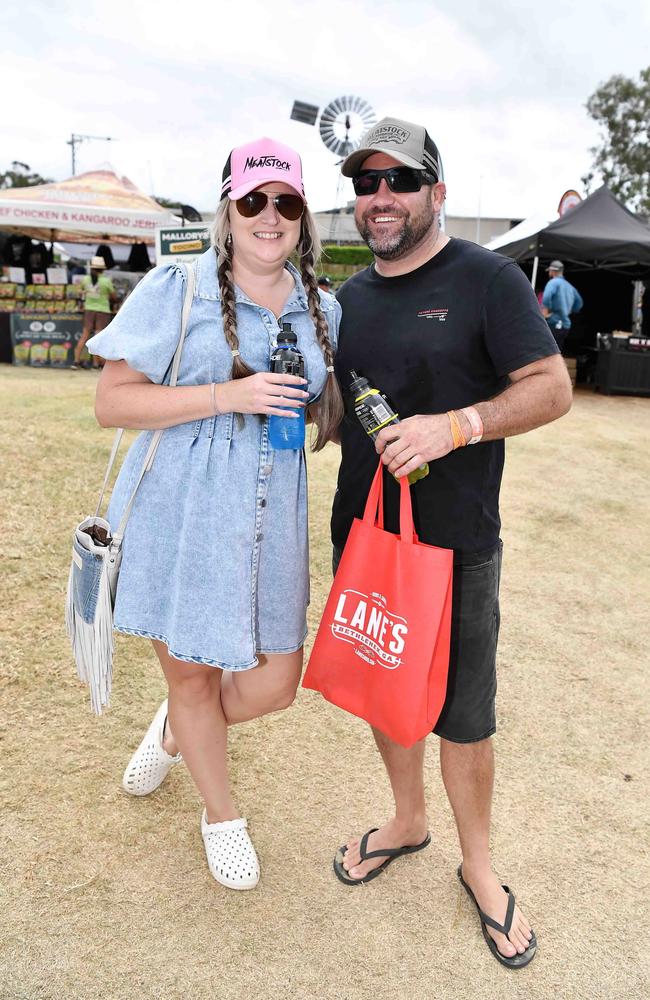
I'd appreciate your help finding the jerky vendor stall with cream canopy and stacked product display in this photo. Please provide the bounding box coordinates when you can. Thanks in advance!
[0,170,178,367]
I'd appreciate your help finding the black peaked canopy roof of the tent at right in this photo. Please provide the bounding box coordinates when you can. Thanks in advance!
[494,186,650,277]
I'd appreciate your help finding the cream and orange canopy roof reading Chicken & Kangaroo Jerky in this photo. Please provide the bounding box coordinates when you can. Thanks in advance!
[0,170,178,244]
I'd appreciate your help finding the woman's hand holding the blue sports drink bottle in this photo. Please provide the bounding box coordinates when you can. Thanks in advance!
[215,372,309,417]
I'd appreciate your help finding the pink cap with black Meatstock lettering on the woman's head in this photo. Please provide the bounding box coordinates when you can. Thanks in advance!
[221,137,306,201]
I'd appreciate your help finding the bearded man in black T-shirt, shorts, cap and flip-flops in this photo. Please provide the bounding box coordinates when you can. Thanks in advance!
[332,118,571,967]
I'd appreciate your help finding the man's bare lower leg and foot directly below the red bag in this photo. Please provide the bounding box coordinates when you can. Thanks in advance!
[336,729,428,879]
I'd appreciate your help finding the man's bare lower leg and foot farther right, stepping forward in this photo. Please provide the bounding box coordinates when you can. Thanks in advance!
[440,739,532,958]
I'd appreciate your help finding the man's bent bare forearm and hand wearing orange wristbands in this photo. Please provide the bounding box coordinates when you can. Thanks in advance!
[376,354,573,476]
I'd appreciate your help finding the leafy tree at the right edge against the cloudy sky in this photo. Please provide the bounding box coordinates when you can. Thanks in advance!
[582,66,650,215]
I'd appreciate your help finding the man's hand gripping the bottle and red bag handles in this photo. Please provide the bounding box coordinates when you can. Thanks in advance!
[375,413,454,478]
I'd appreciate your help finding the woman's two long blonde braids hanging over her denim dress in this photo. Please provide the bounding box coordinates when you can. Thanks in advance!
[211,198,343,451]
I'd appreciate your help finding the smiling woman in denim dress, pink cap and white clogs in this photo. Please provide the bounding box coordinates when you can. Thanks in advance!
[89,138,342,889]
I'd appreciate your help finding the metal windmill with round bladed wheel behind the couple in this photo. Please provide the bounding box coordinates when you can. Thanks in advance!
[291,94,377,240]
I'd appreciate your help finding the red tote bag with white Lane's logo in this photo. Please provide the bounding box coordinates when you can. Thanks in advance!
[302,462,454,747]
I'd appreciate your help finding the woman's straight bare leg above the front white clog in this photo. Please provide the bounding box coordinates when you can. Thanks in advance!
[153,639,239,823]
